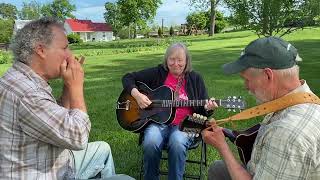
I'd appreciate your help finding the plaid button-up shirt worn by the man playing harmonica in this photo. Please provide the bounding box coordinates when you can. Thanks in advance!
[0,62,91,180]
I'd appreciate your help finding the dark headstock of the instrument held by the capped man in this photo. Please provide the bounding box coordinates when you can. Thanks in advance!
[179,113,207,135]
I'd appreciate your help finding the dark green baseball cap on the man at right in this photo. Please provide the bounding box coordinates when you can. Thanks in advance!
[222,36,302,74]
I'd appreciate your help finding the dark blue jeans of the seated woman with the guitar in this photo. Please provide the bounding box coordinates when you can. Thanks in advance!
[143,123,193,180]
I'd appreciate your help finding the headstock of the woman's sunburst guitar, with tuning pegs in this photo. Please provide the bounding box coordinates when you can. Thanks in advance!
[218,96,246,112]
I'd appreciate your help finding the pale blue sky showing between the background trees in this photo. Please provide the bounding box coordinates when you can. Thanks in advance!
[0,0,201,26]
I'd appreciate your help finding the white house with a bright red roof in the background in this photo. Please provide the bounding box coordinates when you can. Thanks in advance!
[64,19,113,42]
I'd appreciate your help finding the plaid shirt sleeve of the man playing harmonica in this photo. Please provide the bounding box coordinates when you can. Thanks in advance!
[17,91,91,150]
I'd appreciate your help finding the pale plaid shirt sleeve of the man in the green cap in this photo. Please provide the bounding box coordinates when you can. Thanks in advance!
[253,127,312,180]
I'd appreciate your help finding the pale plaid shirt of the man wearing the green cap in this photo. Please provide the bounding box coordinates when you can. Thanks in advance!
[247,81,320,180]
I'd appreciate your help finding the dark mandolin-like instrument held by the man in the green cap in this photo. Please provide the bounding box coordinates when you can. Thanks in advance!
[180,114,260,165]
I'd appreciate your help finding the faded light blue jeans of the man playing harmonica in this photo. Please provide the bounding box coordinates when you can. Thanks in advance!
[71,141,133,180]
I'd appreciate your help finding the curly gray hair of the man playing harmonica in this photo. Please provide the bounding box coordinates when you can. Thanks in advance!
[10,17,64,65]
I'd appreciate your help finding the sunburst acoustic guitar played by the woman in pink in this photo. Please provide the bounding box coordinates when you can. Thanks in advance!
[116,82,245,133]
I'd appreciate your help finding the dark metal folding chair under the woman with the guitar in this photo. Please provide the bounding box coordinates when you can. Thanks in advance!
[139,133,207,180]
